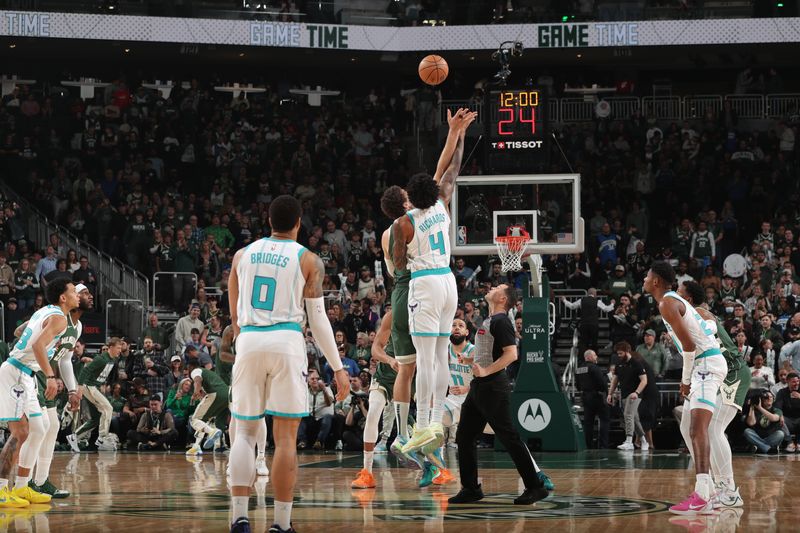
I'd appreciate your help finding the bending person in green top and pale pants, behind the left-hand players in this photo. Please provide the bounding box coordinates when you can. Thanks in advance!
[75,337,122,450]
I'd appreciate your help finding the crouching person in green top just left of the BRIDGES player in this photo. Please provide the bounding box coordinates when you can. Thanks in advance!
[186,360,231,455]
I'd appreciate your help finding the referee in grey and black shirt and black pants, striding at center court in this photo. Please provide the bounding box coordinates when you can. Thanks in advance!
[449,284,548,505]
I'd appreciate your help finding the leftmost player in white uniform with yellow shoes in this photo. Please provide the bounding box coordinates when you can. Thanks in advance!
[0,278,78,507]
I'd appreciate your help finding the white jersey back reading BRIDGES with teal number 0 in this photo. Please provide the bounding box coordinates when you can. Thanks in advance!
[236,238,306,331]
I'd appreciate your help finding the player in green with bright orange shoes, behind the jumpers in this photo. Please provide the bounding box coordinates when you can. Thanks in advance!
[350,311,400,489]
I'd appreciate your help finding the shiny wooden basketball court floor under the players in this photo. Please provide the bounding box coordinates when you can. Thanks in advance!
[0,450,800,533]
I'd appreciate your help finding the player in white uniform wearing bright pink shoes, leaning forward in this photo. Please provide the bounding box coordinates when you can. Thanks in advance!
[644,261,728,515]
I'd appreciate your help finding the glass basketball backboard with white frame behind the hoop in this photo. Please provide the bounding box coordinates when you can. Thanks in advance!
[450,174,584,255]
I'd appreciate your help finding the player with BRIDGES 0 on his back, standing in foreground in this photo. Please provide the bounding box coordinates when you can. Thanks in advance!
[228,195,350,533]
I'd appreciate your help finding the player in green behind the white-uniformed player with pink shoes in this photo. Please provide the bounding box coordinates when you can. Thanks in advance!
[678,281,750,508]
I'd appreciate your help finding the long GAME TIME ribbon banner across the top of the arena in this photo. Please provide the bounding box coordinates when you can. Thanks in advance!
[0,11,800,52]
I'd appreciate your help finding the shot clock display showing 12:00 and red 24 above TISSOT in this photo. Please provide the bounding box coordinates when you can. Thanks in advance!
[484,88,550,171]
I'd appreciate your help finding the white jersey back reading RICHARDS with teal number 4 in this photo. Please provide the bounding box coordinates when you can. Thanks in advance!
[407,200,450,278]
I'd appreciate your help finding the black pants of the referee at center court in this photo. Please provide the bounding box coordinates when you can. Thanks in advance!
[456,371,542,490]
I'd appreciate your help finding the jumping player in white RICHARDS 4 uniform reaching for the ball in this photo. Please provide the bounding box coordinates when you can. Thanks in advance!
[392,109,477,454]
